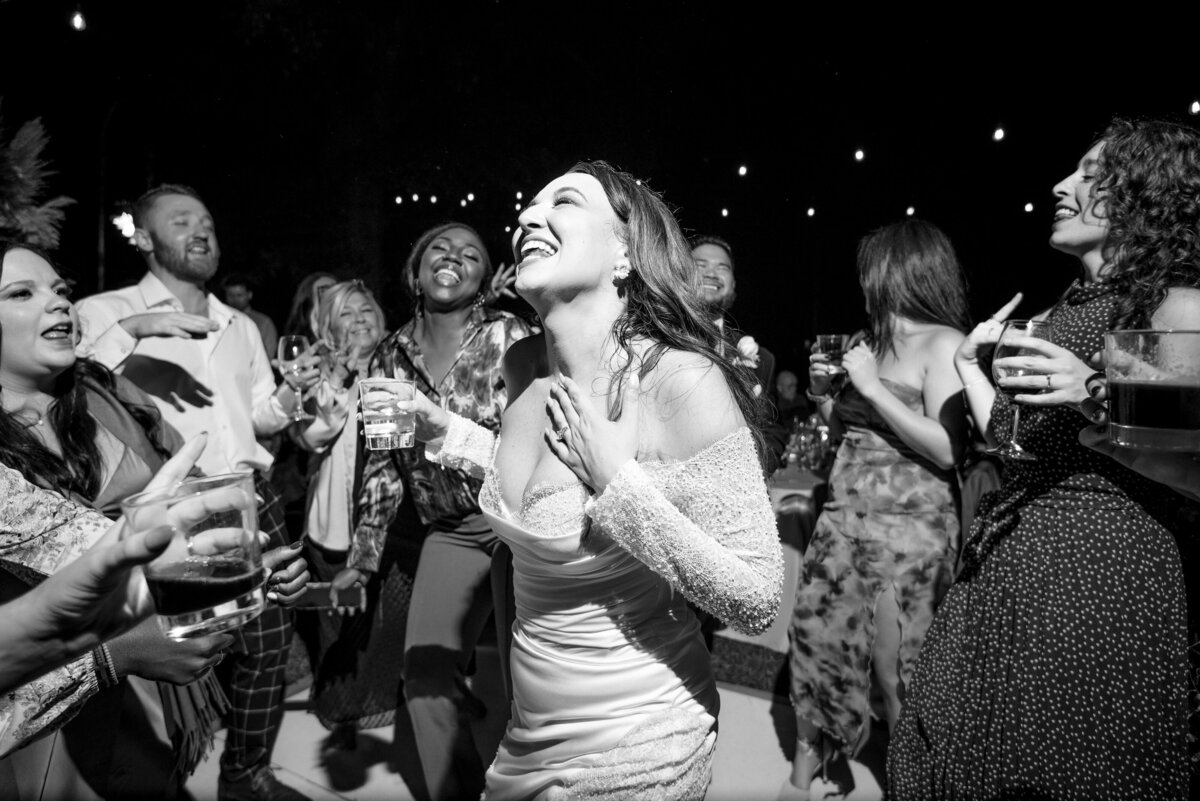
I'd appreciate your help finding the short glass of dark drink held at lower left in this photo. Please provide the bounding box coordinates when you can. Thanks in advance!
[121,472,266,640]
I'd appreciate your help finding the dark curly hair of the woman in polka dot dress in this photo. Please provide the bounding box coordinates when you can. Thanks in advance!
[1096,119,1200,329]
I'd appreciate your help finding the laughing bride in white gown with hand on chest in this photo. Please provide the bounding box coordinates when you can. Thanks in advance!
[398,162,782,800]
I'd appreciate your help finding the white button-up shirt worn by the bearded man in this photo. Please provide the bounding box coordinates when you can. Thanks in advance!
[76,272,295,475]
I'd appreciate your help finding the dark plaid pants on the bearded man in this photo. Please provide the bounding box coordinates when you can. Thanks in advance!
[221,471,292,781]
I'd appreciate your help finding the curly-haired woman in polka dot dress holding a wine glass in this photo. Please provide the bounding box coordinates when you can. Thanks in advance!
[888,120,1200,800]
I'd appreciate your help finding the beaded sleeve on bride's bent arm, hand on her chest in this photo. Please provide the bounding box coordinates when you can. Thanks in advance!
[588,428,784,634]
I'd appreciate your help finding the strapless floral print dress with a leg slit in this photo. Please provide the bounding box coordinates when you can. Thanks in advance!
[791,379,959,754]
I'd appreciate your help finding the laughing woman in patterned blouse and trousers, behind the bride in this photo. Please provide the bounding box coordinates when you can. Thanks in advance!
[335,222,529,800]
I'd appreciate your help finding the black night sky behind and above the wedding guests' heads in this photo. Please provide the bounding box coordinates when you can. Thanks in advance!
[0,0,1200,369]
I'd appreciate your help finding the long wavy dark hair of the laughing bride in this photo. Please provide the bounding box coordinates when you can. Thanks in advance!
[568,161,763,457]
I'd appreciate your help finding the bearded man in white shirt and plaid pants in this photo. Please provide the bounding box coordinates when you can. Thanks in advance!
[77,185,317,801]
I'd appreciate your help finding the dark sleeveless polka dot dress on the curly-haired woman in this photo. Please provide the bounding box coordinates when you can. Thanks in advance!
[888,283,1188,801]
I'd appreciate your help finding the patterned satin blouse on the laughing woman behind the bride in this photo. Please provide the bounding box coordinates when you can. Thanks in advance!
[347,307,532,573]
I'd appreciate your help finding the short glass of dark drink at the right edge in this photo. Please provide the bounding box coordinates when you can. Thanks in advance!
[1104,330,1200,452]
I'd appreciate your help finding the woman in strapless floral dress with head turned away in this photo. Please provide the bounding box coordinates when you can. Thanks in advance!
[791,219,970,790]
